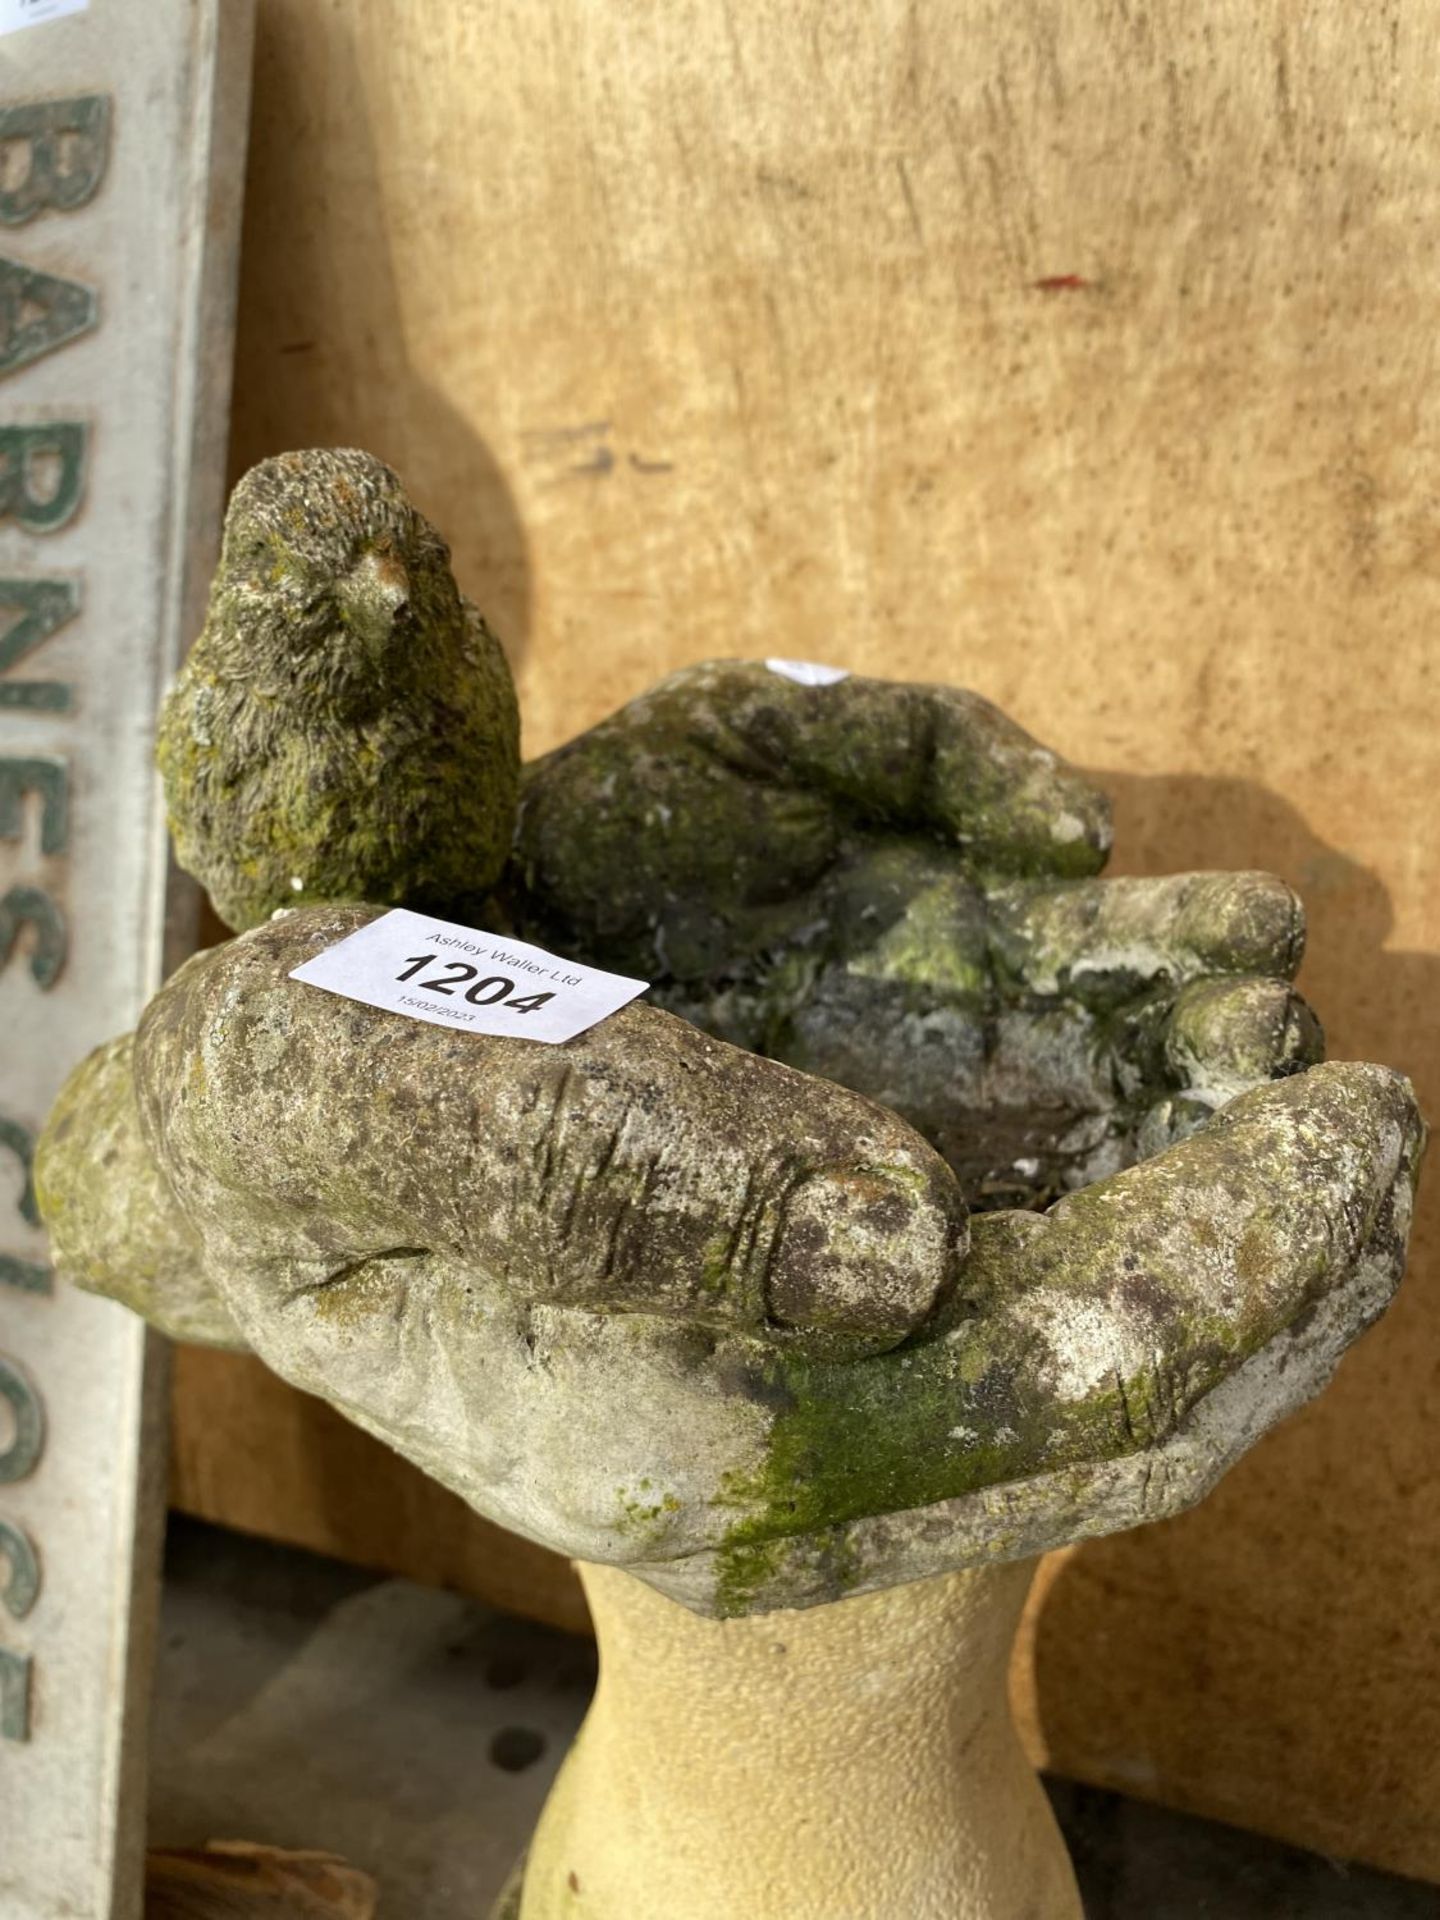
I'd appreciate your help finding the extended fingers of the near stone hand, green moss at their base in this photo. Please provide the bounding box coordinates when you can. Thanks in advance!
[645,1064,1425,1613]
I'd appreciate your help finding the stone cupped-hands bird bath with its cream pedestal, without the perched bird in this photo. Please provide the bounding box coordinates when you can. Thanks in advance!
[38,464,1423,1920]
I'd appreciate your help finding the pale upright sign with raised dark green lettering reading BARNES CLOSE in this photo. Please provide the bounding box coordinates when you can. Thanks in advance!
[0,0,252,1920]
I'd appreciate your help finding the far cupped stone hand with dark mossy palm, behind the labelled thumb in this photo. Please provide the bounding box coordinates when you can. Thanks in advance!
[511,662,1321,1208]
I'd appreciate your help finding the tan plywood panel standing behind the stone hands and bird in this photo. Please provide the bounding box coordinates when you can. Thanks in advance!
[177,0,1440,1880]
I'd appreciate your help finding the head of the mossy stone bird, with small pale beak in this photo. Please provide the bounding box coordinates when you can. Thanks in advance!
[215,447,461,693]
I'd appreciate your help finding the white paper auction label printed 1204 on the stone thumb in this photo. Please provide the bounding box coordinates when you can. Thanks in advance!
[290,906,649,1046]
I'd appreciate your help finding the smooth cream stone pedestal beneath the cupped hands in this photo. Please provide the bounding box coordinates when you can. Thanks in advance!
[495,1563,1081,1920]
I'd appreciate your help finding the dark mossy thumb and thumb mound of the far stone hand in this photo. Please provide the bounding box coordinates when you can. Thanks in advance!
[516,660,1110,981]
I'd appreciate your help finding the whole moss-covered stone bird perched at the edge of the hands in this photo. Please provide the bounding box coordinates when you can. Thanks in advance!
[157,449,520,929]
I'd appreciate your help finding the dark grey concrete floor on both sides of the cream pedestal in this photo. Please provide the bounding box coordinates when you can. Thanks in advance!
[150,1519,1440,1920]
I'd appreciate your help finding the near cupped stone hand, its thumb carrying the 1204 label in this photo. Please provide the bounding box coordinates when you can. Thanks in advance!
[38,908,1421,1613]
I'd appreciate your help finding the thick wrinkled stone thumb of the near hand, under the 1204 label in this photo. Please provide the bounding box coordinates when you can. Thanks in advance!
[136,908,966,1352]
